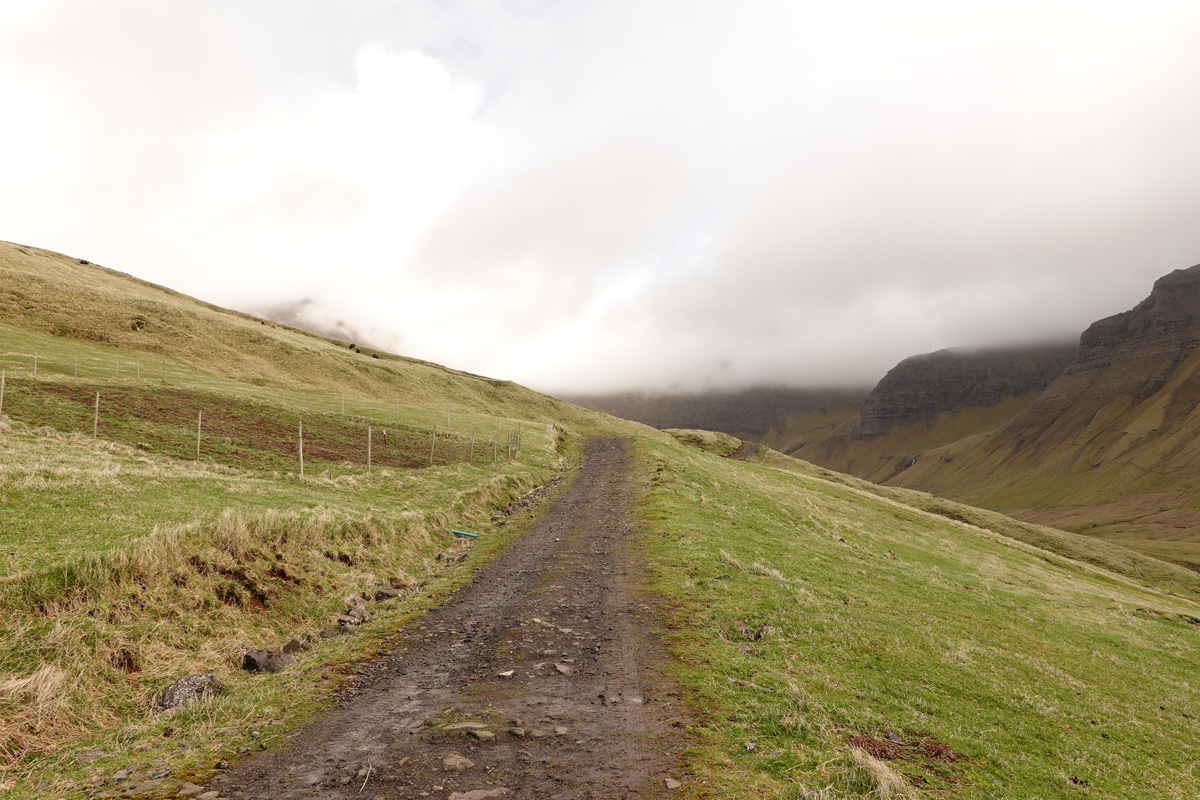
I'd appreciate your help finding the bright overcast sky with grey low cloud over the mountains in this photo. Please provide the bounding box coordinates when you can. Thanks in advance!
[0,0,1200,392]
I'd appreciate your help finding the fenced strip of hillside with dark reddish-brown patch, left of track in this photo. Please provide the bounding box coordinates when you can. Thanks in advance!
[0,340,554,470]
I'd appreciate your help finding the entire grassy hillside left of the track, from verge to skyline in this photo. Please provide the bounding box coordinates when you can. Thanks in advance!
[0,237,662,798]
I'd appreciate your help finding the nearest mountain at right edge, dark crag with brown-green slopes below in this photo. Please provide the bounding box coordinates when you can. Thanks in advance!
[889,266,1200,567]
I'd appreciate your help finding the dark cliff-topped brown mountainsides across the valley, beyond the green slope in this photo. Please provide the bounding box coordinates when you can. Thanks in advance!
[574,266,1200,569]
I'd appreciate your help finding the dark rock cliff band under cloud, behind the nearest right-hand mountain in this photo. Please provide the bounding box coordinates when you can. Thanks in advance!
[839,344,1076,437]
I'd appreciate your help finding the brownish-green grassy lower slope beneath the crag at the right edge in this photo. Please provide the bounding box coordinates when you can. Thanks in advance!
[888,353,1200,570]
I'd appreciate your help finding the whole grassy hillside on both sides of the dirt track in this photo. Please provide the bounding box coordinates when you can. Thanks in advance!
[0,246,1200,799]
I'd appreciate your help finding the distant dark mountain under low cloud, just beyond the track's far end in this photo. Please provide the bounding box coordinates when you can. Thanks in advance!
[563,387,866,450]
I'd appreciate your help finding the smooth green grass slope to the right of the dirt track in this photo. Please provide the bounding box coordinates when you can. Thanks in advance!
[638,440,1200,798]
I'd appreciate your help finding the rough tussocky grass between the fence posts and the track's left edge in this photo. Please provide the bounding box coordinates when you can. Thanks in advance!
[0,407,574,798]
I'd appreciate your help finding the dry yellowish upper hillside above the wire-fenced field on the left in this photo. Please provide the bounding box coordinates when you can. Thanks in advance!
[0,242,636,433]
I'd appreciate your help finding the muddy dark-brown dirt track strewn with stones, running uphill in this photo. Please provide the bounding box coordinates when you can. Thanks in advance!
[211,439,684,800]
